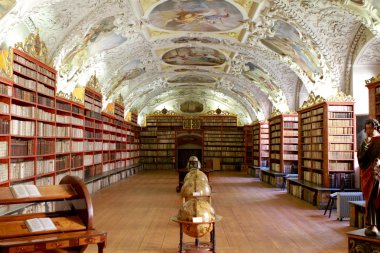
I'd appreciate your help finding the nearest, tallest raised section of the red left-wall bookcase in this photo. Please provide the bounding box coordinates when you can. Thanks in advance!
[8,49,56,185]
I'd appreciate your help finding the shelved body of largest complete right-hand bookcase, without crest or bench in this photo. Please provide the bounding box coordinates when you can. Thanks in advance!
[298,102,356,188]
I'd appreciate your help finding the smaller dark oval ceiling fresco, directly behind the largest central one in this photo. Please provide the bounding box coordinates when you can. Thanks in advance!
[162,47,226,66]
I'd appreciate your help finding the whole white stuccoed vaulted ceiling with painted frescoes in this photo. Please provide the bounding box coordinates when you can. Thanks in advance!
[0,0,380,124]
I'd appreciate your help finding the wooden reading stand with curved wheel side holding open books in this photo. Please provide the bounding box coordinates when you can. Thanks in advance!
[0,176,107,253]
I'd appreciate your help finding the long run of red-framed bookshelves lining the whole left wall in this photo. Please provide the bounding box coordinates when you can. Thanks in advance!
[0,45,140,191]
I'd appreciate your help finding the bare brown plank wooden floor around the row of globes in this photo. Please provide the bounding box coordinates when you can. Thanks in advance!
[85,171,354,253]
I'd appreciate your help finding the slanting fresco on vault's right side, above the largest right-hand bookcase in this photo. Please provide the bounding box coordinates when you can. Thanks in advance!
[261,20,322,82]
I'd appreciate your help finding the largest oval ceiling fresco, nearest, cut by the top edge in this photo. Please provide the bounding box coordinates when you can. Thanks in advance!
[148,0,244,32]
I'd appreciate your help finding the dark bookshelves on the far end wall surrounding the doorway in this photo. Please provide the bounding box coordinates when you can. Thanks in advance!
[140,115,244,170]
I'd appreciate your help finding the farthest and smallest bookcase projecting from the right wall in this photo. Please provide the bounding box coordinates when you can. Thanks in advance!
[252,122,269,167]
